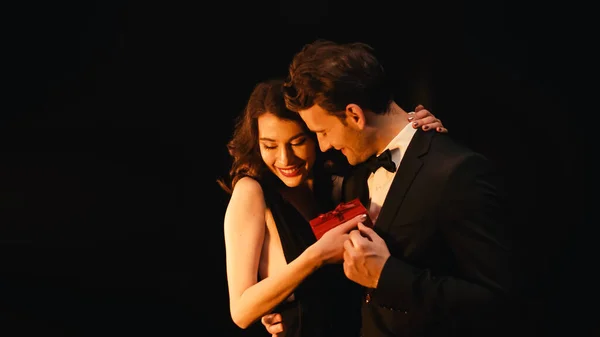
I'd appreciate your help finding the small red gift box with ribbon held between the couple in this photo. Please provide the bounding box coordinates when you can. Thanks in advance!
[310,199,373,240]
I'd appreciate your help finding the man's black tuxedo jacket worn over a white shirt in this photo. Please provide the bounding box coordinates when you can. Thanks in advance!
[342,130,512,337]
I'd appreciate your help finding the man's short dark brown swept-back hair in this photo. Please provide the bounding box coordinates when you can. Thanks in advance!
[284,40,393,114]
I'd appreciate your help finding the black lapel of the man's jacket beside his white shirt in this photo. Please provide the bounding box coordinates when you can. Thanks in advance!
[375,129,436,232]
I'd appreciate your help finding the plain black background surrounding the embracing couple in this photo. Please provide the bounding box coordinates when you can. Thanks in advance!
[0,0,597,337]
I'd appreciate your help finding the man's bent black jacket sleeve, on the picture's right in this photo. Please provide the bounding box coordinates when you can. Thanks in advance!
[371,155,511,318]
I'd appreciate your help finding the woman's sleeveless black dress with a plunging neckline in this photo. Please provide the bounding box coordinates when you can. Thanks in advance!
[263,186,362,337]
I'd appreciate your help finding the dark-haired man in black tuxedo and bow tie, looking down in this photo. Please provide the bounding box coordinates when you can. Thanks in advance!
[262,40,512,337]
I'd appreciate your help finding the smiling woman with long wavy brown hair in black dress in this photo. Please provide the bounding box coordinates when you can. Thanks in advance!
[219,80,446,337]
